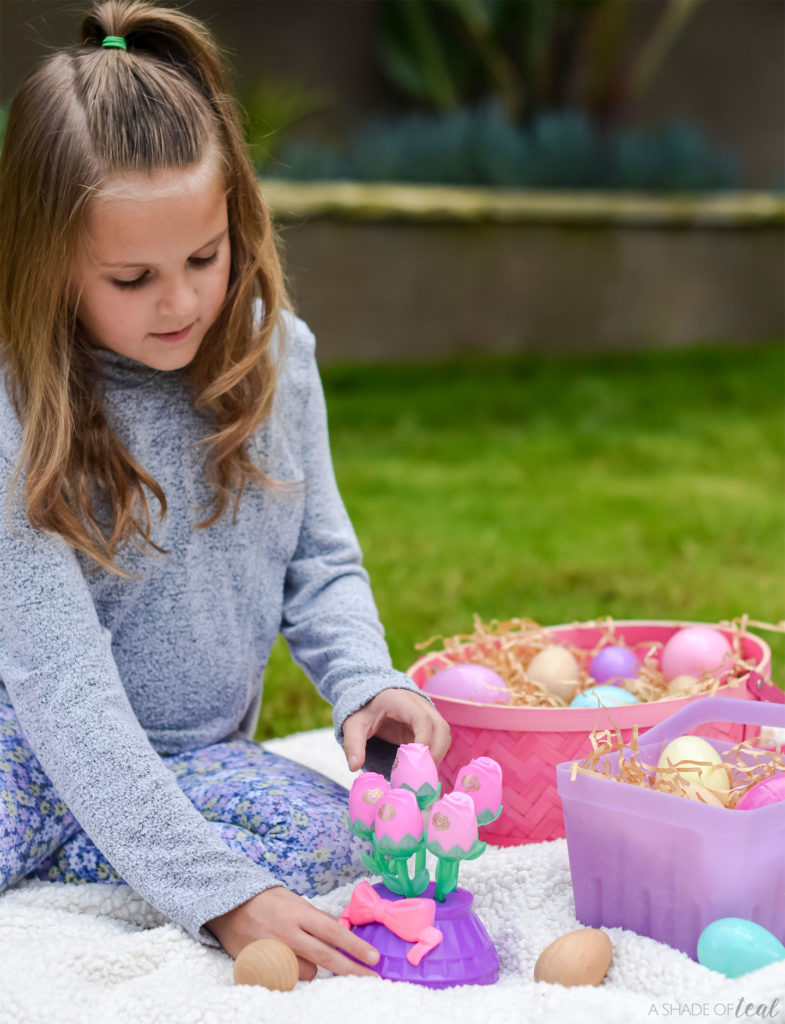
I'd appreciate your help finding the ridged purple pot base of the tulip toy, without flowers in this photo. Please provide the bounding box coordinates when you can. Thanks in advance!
[352,882,498,988]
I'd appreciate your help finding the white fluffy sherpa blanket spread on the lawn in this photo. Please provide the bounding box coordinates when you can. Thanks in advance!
[0,729,785,1024]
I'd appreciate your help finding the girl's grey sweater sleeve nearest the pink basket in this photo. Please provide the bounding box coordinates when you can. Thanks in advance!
[280,321,429,742]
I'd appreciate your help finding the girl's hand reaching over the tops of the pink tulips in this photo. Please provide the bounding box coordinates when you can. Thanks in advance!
[344,689,449,771]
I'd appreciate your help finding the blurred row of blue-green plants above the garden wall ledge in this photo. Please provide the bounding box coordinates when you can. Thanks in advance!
[261,100,740,191]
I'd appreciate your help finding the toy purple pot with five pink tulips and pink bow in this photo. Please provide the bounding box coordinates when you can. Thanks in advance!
[340,743,501,988]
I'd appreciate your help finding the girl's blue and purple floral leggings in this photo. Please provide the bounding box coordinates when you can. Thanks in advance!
[0,703,367,896]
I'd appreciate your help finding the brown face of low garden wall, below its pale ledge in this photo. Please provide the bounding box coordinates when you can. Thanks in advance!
[274,219,785,362]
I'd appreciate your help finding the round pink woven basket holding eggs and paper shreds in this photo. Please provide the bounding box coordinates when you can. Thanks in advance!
[407,620,785,846]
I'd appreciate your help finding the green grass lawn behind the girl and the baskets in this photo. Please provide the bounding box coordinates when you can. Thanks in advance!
[257,343,785,739]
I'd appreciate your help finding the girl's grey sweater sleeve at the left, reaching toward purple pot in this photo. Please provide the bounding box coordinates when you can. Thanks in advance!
[0,455,278,946]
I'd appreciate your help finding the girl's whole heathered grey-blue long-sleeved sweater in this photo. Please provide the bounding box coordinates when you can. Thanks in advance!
[0,313,417,945]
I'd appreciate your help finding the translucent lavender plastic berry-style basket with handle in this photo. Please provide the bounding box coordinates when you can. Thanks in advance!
[557,697,785,959]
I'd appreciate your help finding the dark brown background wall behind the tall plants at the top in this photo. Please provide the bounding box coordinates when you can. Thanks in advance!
[0,0,785,187]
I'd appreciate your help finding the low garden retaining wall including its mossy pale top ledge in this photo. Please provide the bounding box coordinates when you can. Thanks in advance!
[261,179,785,361]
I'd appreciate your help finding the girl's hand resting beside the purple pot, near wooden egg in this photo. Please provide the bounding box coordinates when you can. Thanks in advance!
[205,886,379,981]
